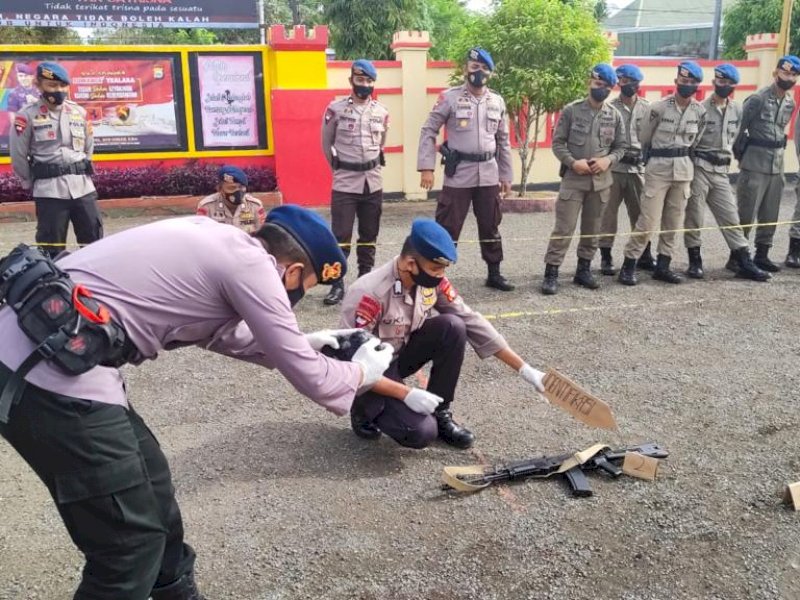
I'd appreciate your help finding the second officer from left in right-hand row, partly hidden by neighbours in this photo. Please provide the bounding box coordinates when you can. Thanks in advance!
[599,64,655,275]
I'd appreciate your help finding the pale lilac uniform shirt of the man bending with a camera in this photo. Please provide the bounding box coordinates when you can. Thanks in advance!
[0,216,361,415]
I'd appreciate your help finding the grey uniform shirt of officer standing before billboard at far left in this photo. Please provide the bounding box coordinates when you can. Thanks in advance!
[9,99,95,199]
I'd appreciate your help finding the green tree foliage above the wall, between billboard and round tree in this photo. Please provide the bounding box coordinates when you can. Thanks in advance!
[323,0,427,60]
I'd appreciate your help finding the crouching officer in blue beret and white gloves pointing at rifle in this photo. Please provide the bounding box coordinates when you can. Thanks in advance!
[341,219,544,448]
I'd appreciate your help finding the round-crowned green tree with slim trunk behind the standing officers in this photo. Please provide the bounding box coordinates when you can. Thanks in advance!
[452,0,611,194]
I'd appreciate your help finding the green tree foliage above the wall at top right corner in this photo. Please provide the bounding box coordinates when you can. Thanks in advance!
[722,0,800,59]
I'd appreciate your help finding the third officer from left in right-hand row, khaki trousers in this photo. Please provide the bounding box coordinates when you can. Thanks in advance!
[619,61,706,285]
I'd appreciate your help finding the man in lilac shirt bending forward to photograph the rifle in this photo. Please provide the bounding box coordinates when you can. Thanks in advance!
[0,206,412,600]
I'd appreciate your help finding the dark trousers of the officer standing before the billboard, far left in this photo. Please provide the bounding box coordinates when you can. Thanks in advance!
[33,192,103,258]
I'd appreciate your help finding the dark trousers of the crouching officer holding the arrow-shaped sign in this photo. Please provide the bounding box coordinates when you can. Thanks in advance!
[355,315,467,448]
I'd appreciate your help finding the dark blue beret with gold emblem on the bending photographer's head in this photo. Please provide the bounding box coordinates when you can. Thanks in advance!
[267,204,347,285]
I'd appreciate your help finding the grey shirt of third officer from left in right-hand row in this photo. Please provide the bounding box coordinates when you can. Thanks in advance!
[639,95,706,181]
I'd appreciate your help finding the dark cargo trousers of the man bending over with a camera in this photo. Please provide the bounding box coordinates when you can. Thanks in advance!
[0,364,195,600]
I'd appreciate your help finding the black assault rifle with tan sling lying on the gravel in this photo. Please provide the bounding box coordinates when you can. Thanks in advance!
[442,442,669,498]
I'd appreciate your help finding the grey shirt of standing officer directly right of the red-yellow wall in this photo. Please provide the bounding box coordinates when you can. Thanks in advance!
[322,96,389,194]
